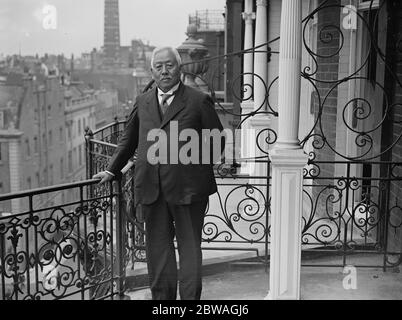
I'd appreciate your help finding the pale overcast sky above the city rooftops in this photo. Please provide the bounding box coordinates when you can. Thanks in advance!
[0,0,225,56]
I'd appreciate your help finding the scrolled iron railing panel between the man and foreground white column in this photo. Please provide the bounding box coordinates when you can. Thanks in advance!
[202,159,271,254]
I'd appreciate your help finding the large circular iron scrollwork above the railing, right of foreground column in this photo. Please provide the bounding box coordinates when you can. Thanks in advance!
[302,0,402,161]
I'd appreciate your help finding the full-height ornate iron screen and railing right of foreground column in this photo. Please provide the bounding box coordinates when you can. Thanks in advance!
[301,0,402,269]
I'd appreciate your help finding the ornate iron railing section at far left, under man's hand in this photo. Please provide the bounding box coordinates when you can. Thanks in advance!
[0,181,122,300]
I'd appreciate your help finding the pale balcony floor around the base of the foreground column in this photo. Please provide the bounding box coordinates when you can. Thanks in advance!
[127,255,402,300]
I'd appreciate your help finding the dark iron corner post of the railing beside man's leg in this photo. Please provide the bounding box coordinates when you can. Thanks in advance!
[113,180,126,298]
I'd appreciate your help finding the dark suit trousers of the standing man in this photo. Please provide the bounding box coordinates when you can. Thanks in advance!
[142,194,208,300]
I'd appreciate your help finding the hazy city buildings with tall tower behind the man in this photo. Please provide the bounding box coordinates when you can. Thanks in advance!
[0,0,224,215]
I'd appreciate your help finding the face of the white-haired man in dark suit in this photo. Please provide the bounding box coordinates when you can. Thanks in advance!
[151,49,180,92]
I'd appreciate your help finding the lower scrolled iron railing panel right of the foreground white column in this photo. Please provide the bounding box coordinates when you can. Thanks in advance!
[302,161,402,269]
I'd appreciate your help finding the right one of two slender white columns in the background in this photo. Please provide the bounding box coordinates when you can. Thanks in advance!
[254,0,268,111]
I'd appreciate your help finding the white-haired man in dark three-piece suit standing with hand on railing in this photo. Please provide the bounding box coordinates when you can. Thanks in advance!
[94,47,223,300]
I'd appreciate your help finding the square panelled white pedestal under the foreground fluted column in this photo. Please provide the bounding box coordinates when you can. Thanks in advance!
[266,147,307,300]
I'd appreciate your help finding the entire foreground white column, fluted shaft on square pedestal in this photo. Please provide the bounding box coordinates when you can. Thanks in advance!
[267,0,307,300]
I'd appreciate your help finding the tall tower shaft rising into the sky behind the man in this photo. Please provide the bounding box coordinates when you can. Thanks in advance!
[104,0,120,65]
